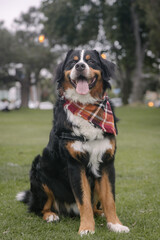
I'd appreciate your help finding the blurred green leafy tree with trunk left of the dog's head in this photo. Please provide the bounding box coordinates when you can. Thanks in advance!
[0,8,56,107]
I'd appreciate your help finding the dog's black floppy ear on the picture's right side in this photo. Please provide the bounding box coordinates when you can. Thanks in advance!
[94,50,116,88]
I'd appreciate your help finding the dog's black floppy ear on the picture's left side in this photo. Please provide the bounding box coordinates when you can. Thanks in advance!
[55,49,73,84]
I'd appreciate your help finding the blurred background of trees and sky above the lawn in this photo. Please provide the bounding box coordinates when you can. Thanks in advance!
[0,0,160,110]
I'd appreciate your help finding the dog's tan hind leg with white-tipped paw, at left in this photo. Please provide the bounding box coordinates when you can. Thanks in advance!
[42,185,59,222]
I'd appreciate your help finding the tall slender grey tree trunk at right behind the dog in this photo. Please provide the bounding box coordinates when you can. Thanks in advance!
[131,2,144,102]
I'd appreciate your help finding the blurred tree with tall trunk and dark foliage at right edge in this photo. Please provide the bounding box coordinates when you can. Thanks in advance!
[131,0,160,102]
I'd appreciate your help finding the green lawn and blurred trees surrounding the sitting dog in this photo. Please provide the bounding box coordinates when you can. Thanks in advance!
[0,0,160,240]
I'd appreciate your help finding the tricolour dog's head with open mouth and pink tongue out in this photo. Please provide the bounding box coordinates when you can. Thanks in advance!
[56,50,115,102]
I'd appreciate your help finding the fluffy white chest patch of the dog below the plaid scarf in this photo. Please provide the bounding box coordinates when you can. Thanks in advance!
[66,110,112,177]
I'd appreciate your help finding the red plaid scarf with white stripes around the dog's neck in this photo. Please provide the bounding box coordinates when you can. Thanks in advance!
[64,94,116,135]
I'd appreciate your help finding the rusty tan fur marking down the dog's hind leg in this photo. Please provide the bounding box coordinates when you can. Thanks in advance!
[42,184,57,221]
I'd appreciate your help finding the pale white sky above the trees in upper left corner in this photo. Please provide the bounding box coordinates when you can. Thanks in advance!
[0,0,41,30]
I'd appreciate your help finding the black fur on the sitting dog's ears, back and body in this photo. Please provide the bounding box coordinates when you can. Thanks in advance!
[18,50,119,225]
